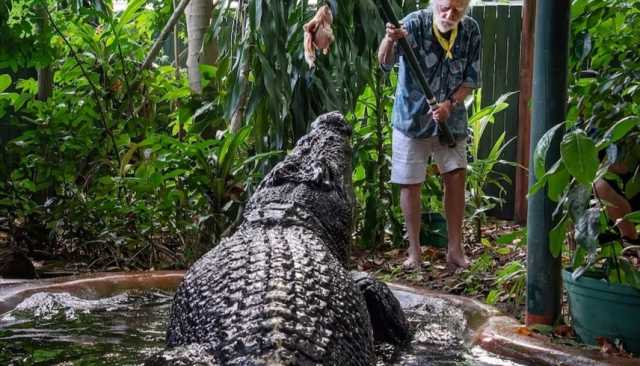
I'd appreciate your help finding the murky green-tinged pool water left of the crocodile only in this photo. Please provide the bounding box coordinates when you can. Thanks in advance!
[0,292,172,365]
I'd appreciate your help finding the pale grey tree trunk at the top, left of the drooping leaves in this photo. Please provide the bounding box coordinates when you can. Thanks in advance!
[185,0,217,94]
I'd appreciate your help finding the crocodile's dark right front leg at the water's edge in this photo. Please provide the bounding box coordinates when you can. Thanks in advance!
[351,271,410,345]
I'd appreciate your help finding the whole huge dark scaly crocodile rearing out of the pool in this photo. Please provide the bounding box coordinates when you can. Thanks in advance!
[147,112,410,365]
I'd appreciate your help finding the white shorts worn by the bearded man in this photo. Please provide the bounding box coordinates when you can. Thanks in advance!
[391,129,467,184]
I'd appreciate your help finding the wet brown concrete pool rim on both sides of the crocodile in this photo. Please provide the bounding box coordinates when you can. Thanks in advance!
[0,271,640,366]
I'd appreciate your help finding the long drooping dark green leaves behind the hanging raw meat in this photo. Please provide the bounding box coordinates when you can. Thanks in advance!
[212,0,384,151]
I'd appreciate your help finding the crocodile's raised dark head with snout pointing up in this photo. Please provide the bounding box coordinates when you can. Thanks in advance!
[244,112,354,264]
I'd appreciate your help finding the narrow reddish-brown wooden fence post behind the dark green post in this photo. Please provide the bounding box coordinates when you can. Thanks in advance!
[514,0,536,224]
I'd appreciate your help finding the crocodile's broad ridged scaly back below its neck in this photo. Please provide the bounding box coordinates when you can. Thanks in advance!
[168,227,373,365]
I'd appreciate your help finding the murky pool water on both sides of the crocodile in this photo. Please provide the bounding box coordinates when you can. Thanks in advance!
[0,291,517,365]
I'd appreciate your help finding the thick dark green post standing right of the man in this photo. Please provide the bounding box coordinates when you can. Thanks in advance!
[526,0,571,324]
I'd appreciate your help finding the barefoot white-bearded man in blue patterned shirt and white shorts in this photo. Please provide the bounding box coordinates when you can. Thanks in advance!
[378,0,480,269]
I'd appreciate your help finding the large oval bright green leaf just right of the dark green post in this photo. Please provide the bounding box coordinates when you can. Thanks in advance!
[560,130,599,185]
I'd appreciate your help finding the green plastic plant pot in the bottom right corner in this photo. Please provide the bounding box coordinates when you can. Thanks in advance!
[562,269,640,354]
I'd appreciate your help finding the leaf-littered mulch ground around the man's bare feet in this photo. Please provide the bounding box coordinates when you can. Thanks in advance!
[352,221,526,320]
